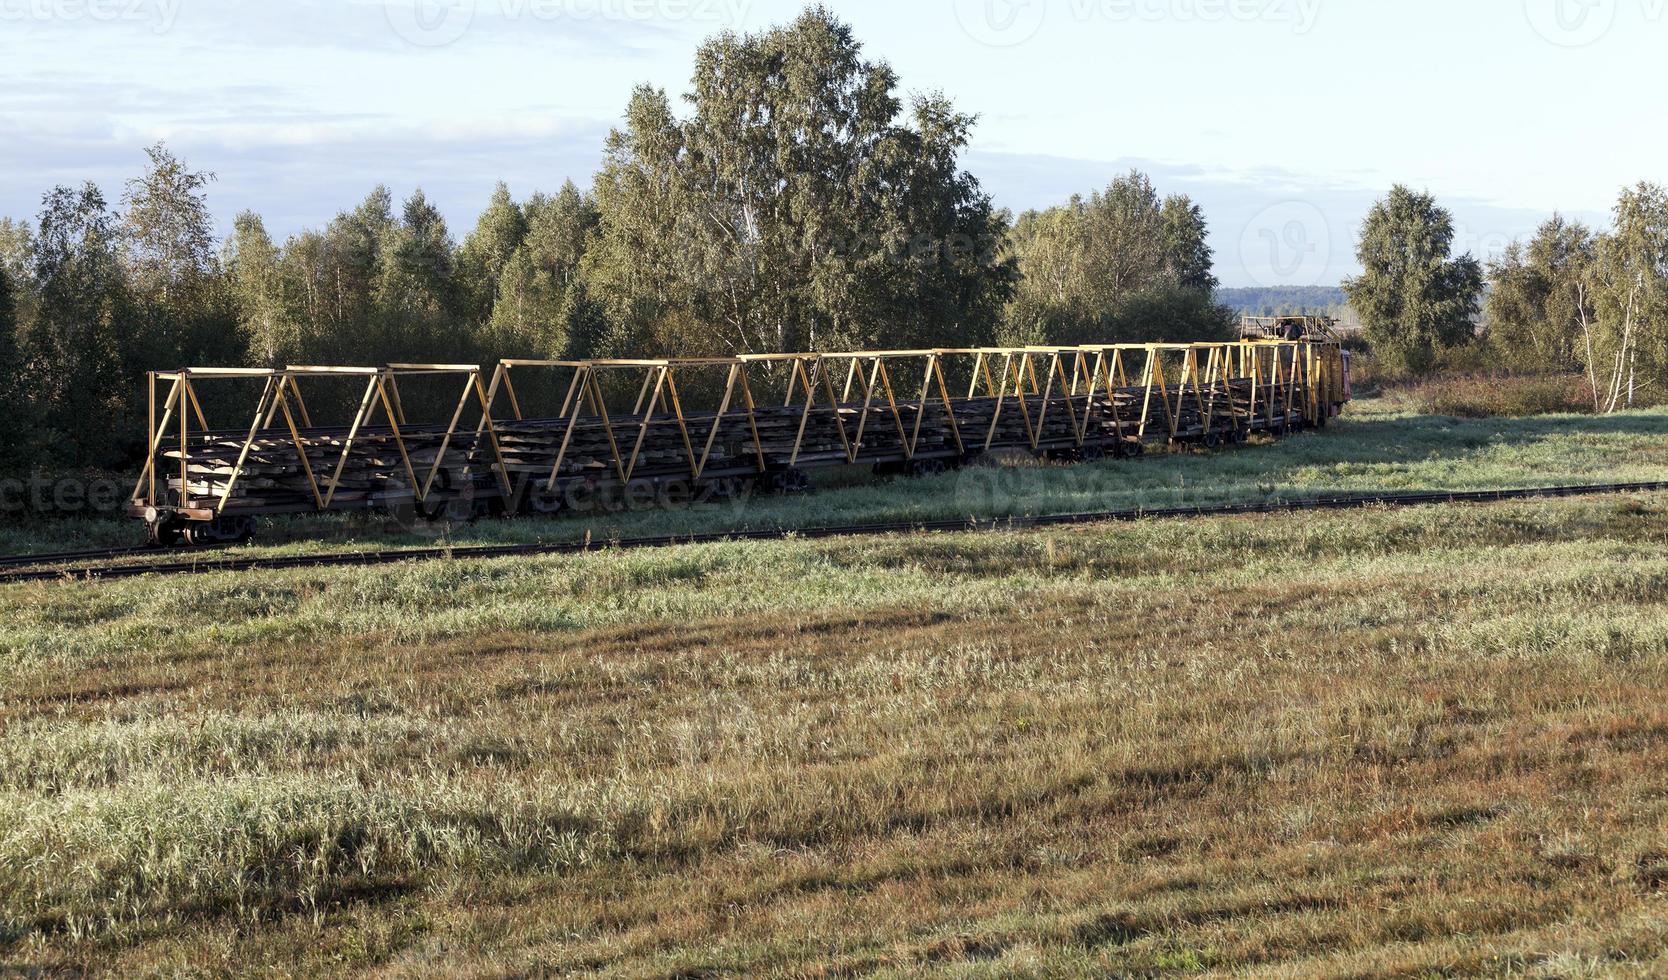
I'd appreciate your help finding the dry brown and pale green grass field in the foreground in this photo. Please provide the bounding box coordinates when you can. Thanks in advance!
[0,398,1668,977]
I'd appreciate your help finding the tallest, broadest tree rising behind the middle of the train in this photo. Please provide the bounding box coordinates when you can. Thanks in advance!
[573,8,1014,353]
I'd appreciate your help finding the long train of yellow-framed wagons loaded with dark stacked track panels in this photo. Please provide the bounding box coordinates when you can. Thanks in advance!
[130,340,1349,543]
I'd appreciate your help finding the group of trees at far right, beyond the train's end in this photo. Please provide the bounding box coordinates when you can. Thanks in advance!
[1344,183,1668,412]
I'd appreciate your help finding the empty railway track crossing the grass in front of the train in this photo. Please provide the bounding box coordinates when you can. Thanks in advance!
[0,482,1668,583]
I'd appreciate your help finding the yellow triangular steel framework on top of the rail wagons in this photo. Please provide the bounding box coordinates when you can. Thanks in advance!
[132,340,1344,517]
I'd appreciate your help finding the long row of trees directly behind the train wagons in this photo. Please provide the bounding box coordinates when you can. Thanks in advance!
[0,7,1231,467]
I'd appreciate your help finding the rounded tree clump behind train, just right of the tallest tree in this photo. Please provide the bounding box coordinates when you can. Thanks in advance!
[1004,170,1231,343]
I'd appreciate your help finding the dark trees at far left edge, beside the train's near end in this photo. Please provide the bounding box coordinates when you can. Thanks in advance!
[0,143,245,465]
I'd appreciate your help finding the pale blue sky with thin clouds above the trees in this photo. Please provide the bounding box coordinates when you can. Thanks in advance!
[0,0,1668,287]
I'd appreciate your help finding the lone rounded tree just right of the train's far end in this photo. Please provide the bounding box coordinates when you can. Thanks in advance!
[1344,185,1483,373]
